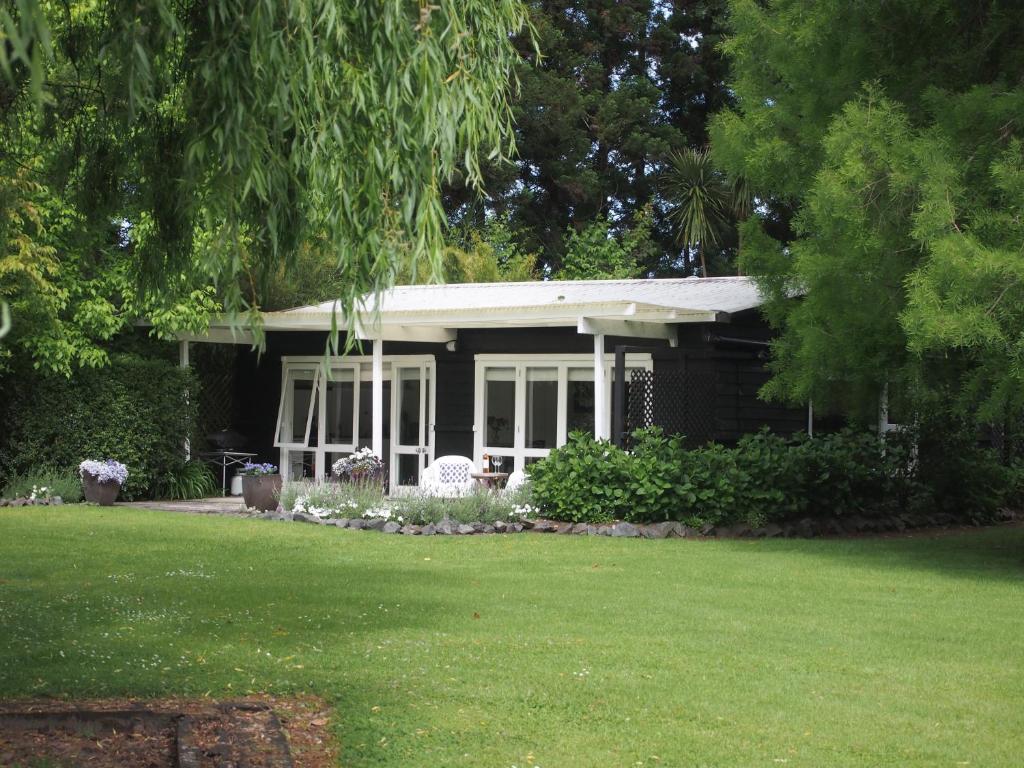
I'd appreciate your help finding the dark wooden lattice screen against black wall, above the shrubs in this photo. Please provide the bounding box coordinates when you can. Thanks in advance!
[626,368,716,446]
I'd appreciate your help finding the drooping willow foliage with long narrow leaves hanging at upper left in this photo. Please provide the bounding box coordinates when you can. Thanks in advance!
[0,0,528,370]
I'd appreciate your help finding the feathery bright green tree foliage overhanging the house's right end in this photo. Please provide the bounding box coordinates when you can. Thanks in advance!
[712,0,1024,419]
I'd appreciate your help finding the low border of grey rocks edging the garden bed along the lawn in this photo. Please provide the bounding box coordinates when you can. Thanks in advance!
[257,509,1024,539]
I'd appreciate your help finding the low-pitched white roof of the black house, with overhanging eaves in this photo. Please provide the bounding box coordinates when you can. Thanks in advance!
[211,278,762,341]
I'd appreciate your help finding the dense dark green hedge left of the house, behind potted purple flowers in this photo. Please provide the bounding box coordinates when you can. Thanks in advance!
[0,354,197,500]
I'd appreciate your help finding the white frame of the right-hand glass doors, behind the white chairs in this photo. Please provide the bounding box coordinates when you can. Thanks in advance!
[473,352,654,472]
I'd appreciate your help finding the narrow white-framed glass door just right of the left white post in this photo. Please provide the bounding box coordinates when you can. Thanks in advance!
[390,362,434,489]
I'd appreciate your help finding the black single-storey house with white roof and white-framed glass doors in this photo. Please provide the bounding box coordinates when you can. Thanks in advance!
[182,278,807,488]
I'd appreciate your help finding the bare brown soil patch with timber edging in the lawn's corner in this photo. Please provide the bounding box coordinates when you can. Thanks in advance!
[0,696,337,768]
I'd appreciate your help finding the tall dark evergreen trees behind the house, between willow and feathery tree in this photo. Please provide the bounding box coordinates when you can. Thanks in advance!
[449,0,729,273]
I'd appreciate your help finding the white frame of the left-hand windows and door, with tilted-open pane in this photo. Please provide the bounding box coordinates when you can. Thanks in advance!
[273,354,437,479]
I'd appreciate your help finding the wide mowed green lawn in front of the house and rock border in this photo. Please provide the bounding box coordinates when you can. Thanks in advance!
[0,507,1024,768]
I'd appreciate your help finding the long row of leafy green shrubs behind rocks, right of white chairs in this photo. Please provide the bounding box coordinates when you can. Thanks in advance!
[530,429,1021,526]
